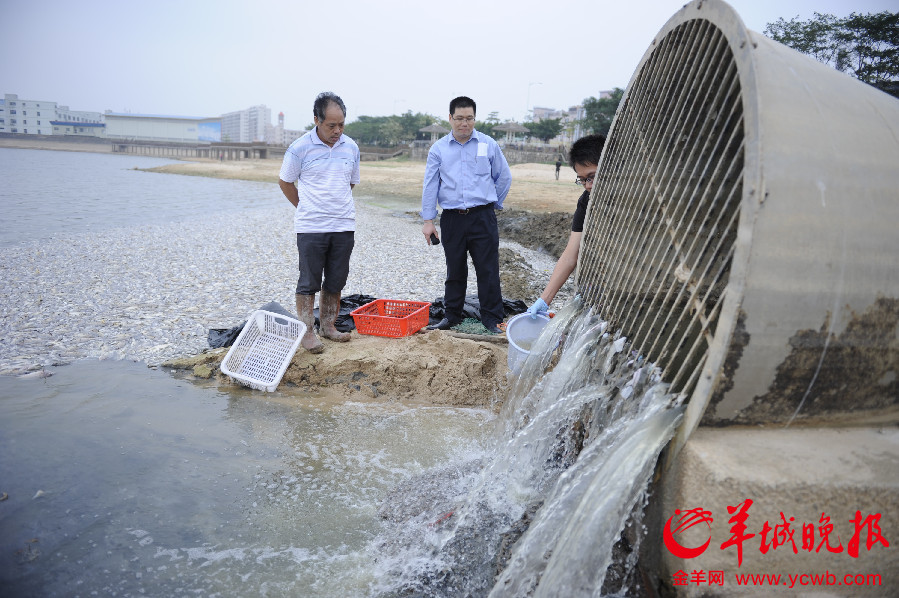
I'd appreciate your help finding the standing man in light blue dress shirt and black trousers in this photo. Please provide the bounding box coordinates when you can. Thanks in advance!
[421,96,512,333]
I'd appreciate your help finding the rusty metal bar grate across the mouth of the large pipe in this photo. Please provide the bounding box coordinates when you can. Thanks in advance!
[577,19,744,404]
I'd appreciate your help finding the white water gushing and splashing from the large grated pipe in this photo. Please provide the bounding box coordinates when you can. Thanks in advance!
[371,299,682,598]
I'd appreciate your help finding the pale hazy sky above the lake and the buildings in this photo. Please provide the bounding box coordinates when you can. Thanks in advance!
[0,0,899,129]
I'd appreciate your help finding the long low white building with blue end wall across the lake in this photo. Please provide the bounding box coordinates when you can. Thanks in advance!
[104,111,222,144]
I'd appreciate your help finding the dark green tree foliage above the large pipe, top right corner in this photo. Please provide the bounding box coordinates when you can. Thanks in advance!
[765,11,899,97]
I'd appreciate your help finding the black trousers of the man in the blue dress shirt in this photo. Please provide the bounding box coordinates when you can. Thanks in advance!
[440,204,505,326]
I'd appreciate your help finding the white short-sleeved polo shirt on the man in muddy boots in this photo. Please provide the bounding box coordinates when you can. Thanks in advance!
[279,128,359,233]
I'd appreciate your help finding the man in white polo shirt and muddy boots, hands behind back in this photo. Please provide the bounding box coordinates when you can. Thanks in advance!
[278,91,359,353]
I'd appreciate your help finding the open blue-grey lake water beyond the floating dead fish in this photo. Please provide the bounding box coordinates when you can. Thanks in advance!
[0,148,286,246]
